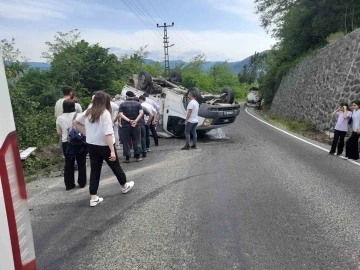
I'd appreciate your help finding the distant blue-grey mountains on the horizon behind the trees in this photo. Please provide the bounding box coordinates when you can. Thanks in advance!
[29,51,268,75]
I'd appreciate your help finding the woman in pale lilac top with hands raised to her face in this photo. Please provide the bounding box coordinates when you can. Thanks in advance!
[329,103,352,156]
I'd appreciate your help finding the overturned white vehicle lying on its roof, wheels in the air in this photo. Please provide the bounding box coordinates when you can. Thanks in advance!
[121,71,240,138]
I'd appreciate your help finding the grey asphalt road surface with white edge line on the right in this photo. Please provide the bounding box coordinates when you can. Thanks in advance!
[28,108,360,270]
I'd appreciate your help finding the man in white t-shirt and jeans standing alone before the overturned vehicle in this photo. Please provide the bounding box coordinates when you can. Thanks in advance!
[181,91,199,150]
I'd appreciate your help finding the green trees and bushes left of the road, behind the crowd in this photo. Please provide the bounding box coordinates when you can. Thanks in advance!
[0,30,256,177]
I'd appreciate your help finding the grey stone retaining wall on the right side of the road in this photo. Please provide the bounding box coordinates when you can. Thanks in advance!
[271,30,360,130]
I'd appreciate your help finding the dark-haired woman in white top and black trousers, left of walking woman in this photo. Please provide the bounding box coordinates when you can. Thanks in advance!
[56,99,87,190]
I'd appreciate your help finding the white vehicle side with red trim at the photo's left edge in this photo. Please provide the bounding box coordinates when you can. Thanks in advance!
[0,55,36,270]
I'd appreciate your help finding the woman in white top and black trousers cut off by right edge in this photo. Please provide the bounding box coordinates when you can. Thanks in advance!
[345,100,360,160]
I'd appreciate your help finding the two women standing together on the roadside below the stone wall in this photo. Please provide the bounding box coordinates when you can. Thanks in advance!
[329,100,360,160]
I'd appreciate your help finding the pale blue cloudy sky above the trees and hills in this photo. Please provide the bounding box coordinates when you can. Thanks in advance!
[0,0,275,62]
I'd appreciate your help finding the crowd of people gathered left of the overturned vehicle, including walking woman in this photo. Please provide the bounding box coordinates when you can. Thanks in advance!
[55,87,160,206]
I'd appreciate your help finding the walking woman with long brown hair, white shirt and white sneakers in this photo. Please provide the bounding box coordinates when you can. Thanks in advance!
[74,91,134,206]
